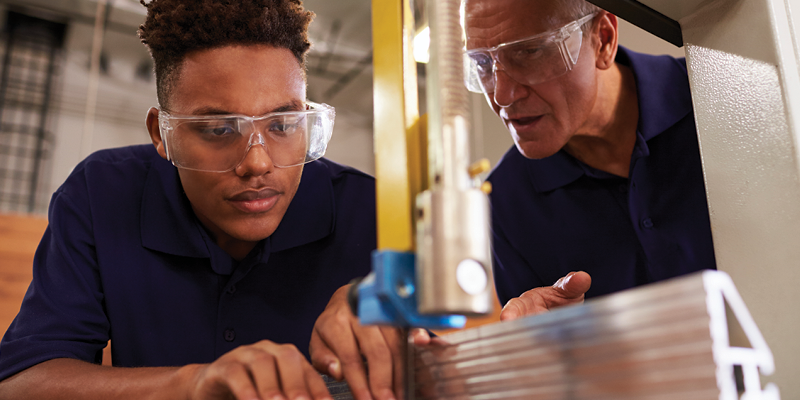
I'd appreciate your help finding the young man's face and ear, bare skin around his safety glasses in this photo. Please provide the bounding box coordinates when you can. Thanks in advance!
[149,45,306,259]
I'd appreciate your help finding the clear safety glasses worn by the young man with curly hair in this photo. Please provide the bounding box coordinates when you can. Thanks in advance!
[158,102,335,172]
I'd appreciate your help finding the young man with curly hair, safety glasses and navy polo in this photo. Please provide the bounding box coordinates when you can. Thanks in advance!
[0,0,376,400]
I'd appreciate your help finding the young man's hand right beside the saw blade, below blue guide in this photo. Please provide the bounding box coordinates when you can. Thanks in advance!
[309,285,430,400]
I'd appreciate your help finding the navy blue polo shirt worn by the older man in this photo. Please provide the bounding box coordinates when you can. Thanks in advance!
[489,47,716,304]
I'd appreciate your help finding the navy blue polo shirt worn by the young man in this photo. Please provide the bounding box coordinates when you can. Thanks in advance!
[0,145,376,379]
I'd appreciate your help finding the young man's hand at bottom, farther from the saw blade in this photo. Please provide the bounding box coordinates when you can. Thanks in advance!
[184,340,332,400]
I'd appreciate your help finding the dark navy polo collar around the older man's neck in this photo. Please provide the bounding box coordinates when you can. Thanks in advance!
[524,46,692,193]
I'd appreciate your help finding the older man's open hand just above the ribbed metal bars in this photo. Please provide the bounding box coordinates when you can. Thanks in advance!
[500,271,592,321]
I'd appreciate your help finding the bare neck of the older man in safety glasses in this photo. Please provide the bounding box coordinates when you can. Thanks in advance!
[564,63,639,178]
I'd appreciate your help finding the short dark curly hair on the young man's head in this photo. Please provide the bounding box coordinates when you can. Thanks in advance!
[138,0,314,108]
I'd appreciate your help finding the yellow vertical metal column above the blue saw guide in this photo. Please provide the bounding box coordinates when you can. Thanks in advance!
[372,0,427,251]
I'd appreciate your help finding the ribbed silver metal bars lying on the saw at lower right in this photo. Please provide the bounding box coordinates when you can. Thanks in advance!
[411,271,779,400]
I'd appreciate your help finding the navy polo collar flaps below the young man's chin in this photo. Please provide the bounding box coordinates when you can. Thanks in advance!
[141,160,335,262]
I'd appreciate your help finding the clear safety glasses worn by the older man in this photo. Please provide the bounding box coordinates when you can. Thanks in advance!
[464,13,597,93]
